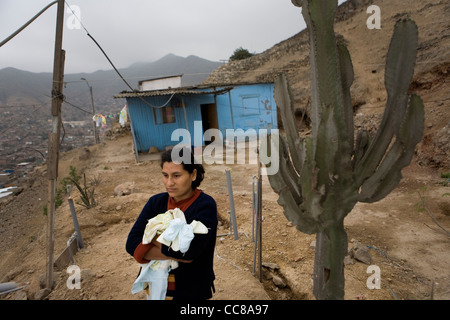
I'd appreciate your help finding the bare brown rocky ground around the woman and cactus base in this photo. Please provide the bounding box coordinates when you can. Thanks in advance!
[0,122,450,300]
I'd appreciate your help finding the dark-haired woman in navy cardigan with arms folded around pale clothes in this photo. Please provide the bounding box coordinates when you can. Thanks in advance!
[126,148,217,300]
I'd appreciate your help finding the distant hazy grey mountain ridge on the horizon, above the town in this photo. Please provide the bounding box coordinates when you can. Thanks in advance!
[0,54,222,120]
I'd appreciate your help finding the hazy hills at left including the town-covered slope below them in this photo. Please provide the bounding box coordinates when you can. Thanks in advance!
[0,54,221,171]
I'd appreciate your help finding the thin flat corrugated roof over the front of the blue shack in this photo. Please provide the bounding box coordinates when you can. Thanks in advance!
[114,87,233,99]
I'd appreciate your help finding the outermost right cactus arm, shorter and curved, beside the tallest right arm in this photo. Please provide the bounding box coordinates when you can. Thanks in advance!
[359,95,425,203]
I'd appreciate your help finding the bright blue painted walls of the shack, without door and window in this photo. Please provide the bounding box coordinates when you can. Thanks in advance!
[127,84,277,153]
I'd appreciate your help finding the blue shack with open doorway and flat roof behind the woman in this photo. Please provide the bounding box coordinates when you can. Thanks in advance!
[115,83,277,160]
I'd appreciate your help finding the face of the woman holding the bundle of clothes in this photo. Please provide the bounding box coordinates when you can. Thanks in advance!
[162,162,197,202]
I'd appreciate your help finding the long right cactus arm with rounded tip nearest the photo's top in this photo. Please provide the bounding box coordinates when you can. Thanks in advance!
[355,20,418,185]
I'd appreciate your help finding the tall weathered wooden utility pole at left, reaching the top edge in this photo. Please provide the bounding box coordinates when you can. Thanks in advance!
[46,0,65,290]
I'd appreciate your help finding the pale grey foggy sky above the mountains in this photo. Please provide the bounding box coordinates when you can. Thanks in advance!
[0,0,312,74]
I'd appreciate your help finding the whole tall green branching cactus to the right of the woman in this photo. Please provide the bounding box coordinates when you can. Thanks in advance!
[268,0,424,299]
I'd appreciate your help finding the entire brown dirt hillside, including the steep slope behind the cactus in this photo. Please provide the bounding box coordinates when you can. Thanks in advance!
[0,0,450,300]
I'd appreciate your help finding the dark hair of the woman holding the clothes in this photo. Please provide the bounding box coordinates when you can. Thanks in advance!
[161,147,205,190]
